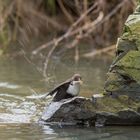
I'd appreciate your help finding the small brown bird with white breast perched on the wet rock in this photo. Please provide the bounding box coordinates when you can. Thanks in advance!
[46,74,82,102]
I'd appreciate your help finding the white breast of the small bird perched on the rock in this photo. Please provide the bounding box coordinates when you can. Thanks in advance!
[67,84,80,96]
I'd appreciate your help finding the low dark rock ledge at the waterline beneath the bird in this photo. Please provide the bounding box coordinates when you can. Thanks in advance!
[40,96,140,126]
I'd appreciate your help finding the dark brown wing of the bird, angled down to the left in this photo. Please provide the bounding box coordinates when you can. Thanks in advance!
[46,80,71,96]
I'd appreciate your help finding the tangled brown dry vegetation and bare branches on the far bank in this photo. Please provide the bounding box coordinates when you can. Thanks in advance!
[0,0,136,75]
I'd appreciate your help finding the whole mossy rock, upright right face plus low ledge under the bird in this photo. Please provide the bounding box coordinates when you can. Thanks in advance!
[40,4,140,126]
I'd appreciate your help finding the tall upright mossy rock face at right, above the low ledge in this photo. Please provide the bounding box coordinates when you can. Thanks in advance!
[105,5,140,100]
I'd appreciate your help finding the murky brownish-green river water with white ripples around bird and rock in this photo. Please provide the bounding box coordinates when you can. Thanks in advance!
[0,57,140,140]
